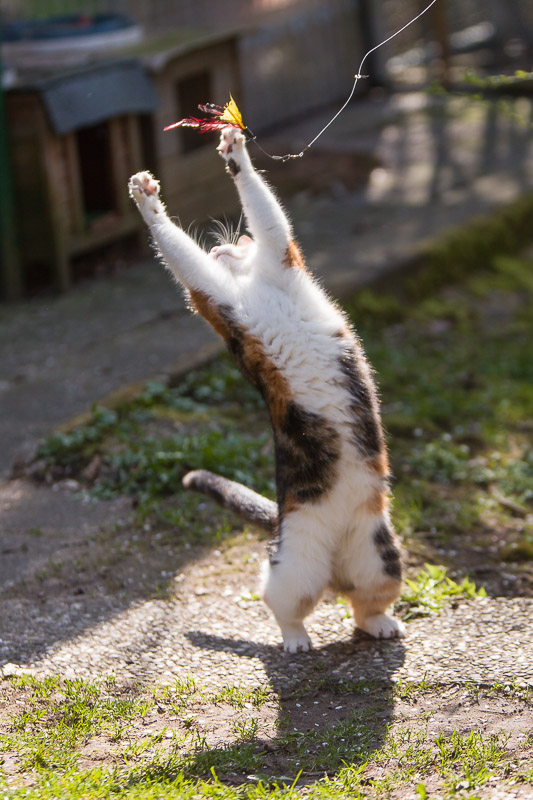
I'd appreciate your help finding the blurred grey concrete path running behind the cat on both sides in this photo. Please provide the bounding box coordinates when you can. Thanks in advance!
[0,94,533,478]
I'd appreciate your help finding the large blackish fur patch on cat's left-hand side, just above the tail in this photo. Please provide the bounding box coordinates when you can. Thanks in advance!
[274,401,340,516]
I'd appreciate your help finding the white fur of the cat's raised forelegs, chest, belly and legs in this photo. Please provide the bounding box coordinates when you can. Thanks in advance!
[130,128,403,653]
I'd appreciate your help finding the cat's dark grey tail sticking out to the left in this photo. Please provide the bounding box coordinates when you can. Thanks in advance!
[182,469,278,533]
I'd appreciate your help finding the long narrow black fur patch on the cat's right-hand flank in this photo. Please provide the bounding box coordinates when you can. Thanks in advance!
[339,352,385,456]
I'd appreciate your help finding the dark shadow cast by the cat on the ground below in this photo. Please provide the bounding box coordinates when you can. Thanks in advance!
[187,631,405,782]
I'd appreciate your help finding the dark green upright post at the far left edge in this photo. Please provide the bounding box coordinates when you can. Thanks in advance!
[0,53,22,300]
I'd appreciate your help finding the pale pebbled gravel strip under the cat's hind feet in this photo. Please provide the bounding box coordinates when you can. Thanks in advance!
[1,540,533,692]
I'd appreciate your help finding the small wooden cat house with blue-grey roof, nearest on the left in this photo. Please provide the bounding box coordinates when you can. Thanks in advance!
[6,60,158,290]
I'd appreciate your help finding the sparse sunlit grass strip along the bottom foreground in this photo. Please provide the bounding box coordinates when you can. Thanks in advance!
[0,678,532,800]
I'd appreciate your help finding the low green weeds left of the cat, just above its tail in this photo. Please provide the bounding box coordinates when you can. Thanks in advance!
[37,357,274,527]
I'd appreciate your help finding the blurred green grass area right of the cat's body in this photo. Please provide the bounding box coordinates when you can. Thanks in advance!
[352,257,533,565]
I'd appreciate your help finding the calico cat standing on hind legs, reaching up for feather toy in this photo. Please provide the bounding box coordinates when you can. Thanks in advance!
[129,128,404,653]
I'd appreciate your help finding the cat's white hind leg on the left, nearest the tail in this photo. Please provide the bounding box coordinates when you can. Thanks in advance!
[263,512,330,653]
